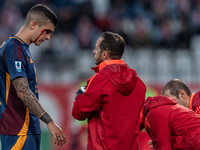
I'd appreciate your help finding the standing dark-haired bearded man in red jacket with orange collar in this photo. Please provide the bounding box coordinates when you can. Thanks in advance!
[72,31,146,150]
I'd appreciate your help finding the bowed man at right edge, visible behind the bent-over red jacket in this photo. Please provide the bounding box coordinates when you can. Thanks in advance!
[162,79,200,114]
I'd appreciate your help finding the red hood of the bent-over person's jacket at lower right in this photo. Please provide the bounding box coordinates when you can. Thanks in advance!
[143,96,177,117]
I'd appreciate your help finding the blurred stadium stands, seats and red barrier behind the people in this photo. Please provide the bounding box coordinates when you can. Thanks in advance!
[0,0,200,150]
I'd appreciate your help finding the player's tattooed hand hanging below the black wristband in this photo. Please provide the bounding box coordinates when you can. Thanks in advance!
[47,120,66,147]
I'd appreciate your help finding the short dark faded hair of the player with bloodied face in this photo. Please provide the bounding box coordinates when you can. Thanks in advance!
[25,4,58,27]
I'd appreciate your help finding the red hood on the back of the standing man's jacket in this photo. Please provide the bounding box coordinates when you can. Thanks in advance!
[100,64,138,95]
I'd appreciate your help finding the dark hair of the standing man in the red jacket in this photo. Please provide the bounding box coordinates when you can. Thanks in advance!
[99,31,125,59]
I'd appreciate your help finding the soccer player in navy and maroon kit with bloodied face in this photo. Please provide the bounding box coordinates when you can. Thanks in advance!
[0,4,66,150]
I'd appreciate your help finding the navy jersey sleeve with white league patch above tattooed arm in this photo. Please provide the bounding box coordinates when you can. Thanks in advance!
[5,43,27,80]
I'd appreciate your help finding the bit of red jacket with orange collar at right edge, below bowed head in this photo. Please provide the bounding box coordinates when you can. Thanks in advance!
[189,91,200,115]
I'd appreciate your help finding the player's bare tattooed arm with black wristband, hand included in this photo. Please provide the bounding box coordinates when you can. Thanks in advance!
[12,77,66,146]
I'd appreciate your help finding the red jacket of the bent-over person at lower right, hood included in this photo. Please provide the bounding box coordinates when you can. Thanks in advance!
[143,96,200,150]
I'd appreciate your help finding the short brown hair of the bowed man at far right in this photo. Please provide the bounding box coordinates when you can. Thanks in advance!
[162,79,192,98]
